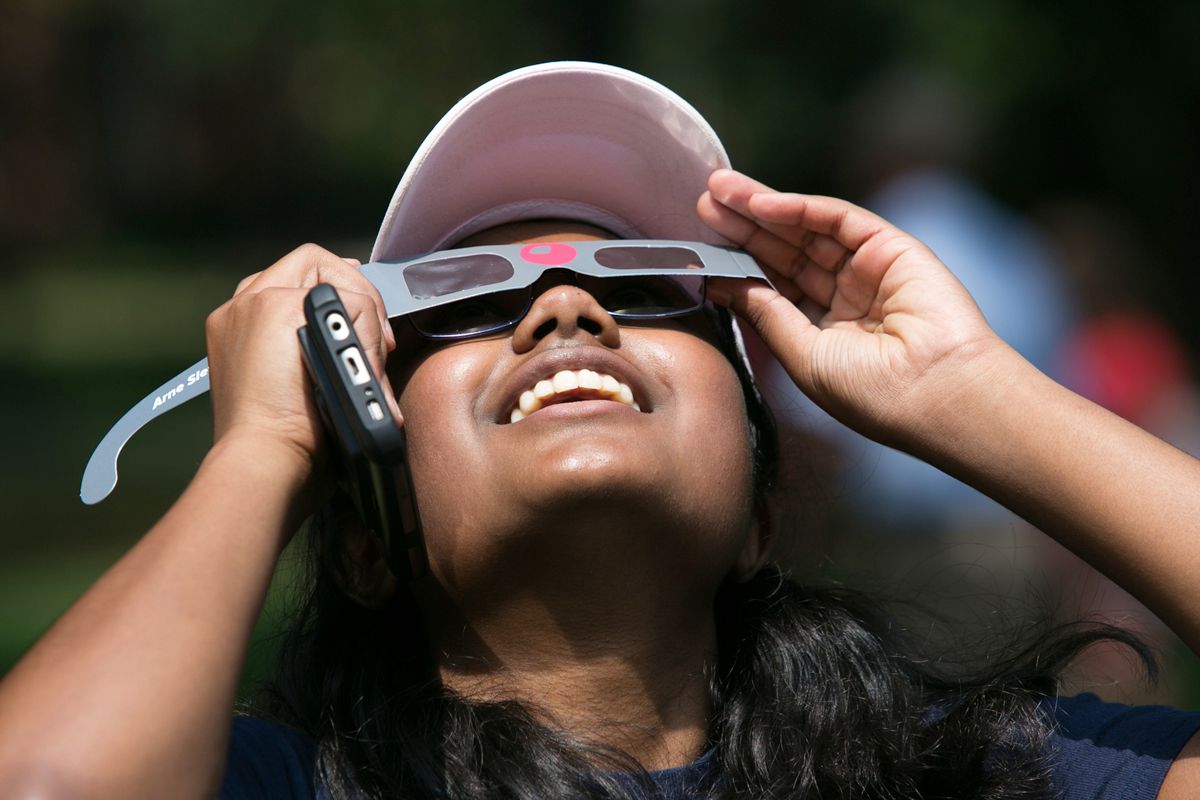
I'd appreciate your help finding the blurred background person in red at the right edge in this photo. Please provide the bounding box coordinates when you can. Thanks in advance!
[1036,197,1200,703]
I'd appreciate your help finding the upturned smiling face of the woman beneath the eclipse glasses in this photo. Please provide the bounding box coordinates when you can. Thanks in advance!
[389,223,754,609]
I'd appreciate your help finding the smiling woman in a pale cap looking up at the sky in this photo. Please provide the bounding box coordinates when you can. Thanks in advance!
[0,64,1200,800]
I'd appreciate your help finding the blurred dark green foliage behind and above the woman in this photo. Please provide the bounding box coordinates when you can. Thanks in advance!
[0,0,1200,700]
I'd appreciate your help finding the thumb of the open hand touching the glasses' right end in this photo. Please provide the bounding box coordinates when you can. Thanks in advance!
[707,278,820,391]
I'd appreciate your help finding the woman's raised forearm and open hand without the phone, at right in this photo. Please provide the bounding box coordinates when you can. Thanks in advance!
[698,170,1200,671]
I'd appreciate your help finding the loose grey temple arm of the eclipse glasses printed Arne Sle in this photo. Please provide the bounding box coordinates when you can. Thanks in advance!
[79,359,209,505]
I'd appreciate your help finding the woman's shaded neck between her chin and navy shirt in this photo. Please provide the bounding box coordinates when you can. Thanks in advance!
[421,561,716,770]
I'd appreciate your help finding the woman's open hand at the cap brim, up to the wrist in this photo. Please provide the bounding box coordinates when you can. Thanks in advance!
[698,169,1012,450]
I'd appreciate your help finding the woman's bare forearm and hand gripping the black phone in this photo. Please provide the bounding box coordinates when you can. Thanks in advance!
[0,245,395,798]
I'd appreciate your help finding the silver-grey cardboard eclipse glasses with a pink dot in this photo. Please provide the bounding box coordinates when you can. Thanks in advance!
[79,239,769,505]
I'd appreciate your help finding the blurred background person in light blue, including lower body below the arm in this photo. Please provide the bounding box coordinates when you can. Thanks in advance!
[772,66,1075,599]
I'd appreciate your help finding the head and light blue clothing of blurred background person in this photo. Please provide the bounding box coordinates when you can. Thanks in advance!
[820,67,1075,535]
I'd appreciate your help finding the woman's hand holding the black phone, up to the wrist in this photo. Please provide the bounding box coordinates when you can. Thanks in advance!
[205,245,400,506]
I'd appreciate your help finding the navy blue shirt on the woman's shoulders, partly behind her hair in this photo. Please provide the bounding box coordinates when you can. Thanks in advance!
[221,694,1200,800]
